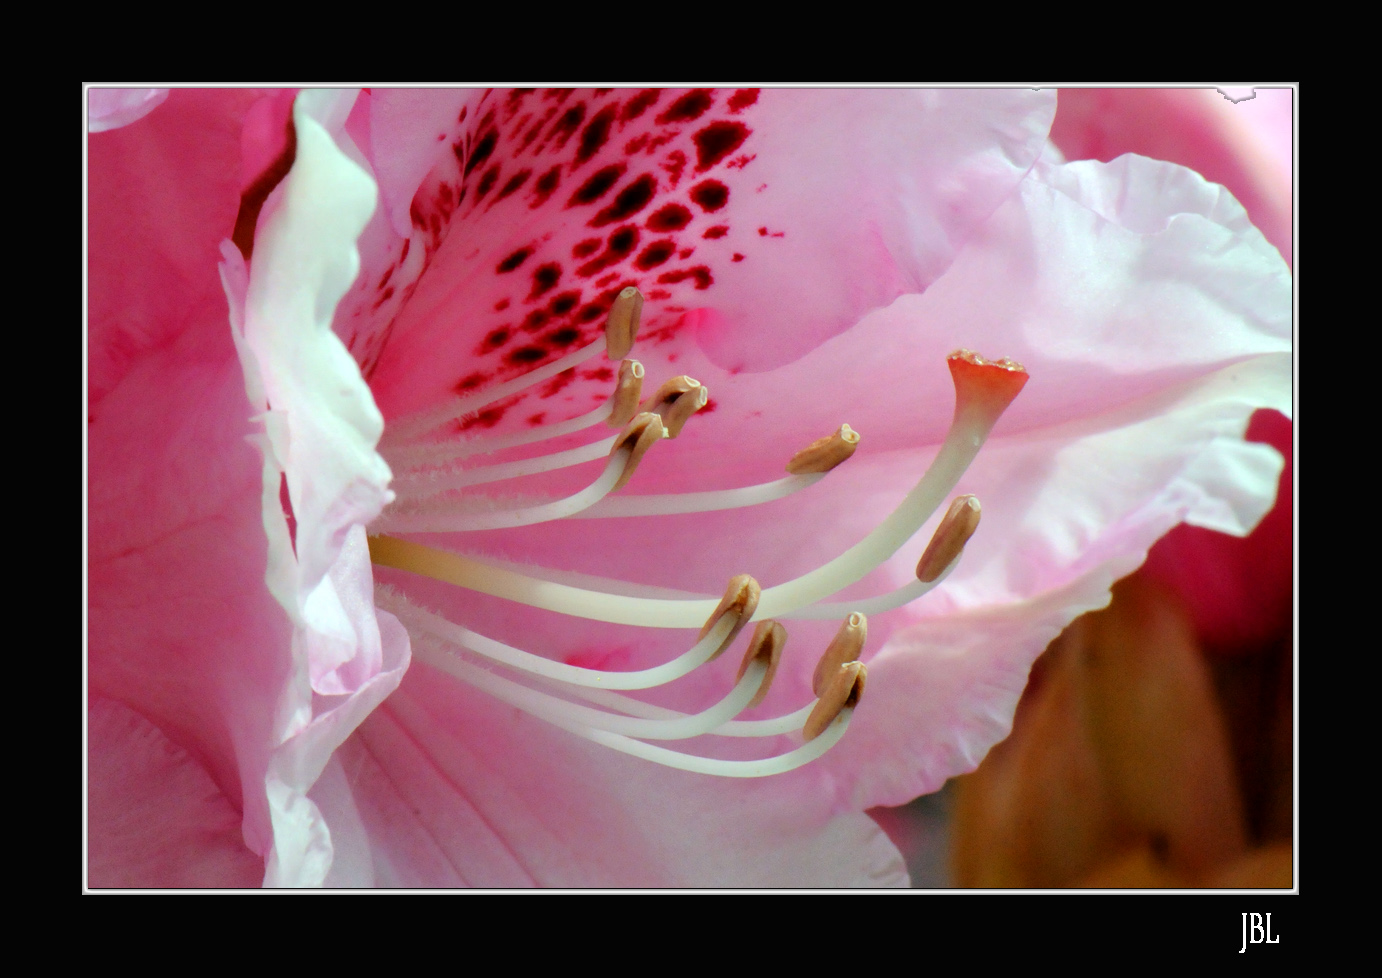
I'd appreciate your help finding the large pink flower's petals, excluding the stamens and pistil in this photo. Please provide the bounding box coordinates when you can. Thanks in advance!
[90,90,1289,885]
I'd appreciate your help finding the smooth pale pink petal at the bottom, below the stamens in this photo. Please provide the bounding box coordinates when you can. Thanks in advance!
[330,666,907,887]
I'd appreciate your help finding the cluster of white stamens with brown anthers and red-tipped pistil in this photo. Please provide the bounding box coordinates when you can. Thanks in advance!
[369,287,1027,778]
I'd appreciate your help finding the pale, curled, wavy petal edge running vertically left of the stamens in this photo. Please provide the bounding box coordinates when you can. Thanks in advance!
[223,93,409,885]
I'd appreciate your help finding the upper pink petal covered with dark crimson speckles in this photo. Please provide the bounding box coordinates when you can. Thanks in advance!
[359,90,1050,424]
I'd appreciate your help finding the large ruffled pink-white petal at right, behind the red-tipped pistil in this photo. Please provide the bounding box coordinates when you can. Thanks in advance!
[383,147,1289,811]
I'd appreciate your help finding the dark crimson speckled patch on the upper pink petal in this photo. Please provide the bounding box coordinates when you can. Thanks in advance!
[359,88,784,427]
